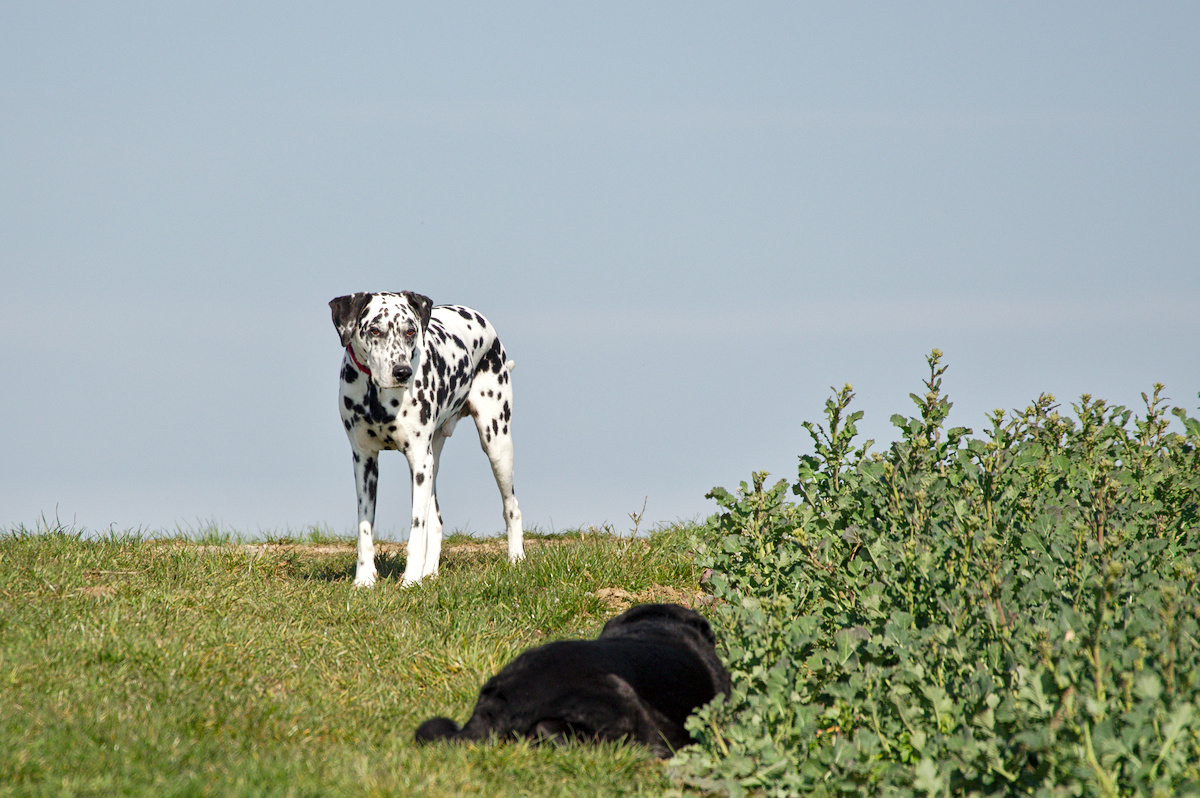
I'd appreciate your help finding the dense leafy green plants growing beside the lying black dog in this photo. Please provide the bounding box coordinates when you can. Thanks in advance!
[674,350,1200,796]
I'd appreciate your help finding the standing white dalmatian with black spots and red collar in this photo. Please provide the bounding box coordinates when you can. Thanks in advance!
[329,292,524,587]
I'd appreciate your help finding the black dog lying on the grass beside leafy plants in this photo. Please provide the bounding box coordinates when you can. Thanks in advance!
[416,604,730,757]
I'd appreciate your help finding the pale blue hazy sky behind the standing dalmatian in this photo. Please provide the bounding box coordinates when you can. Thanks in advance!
[0,2,1200,539]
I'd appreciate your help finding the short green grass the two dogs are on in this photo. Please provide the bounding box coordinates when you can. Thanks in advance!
[0,526,700,796]
